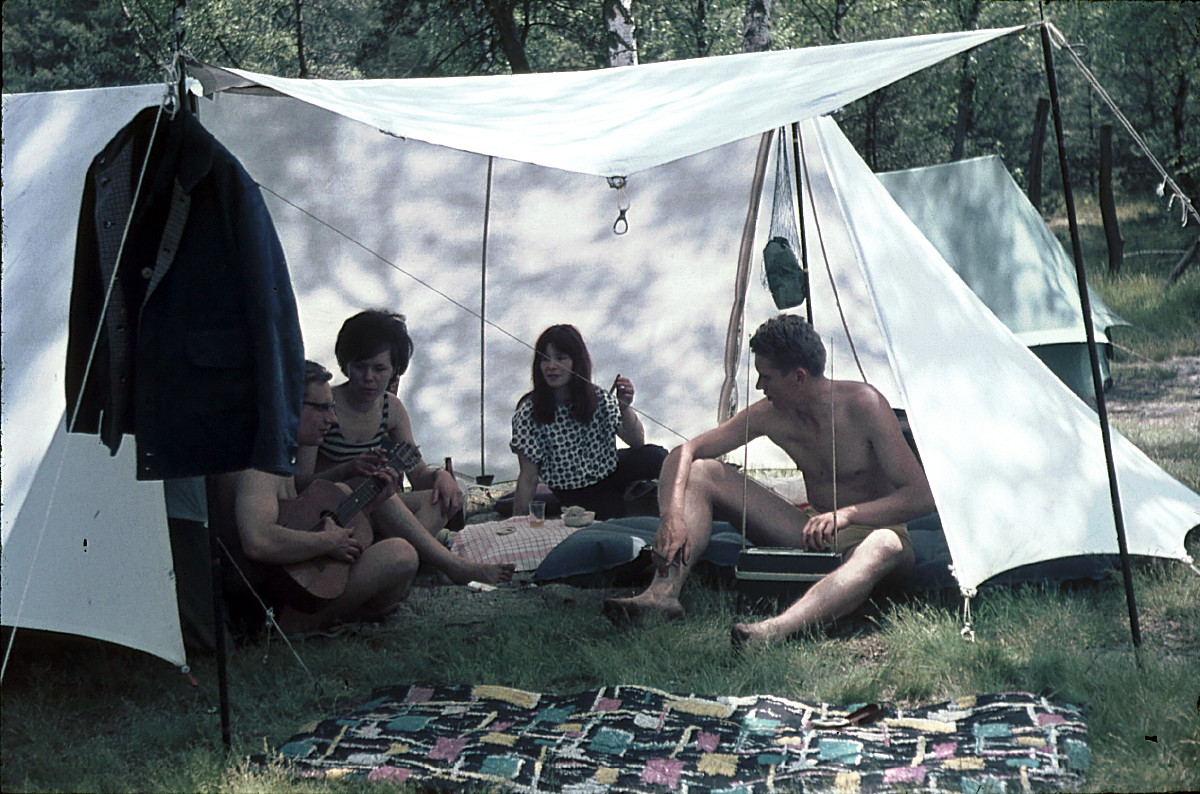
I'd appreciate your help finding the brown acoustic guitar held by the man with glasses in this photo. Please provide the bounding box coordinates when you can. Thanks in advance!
[278,443,421,612]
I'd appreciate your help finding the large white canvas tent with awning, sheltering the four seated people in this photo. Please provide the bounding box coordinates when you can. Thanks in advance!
[2,29,1200,658]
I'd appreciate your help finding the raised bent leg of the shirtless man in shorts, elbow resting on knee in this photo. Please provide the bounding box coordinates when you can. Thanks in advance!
[602,452,806,622]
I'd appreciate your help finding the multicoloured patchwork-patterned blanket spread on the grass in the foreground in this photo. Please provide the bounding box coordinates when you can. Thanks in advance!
[270,685,1090,794]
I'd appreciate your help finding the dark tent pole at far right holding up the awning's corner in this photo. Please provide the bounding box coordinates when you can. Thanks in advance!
[1042,23,1141,667]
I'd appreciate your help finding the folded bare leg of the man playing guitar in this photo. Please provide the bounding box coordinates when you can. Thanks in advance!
[280,537,418,632]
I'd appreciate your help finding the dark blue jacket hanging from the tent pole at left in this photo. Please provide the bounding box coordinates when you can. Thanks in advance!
[66,108,304,480]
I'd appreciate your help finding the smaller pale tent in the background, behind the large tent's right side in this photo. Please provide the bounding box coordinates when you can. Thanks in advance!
[878,155,1128,399]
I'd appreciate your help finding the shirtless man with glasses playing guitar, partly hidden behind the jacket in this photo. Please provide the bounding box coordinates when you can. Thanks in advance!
[215,361,418,632]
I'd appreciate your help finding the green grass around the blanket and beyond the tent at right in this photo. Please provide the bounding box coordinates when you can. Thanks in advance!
[0,202,1200,793]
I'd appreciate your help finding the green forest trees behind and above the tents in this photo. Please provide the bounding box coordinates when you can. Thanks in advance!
[2,0,1200,215]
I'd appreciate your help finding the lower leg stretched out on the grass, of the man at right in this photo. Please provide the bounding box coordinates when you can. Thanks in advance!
[731,529,913,646]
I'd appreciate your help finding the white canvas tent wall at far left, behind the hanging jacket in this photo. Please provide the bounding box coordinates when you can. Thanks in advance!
[0,85,185,664]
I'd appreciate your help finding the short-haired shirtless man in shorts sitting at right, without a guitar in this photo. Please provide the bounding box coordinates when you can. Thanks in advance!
[604,314,934,645]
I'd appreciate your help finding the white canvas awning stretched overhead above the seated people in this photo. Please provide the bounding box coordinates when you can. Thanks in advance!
[192,26,1024,176]
